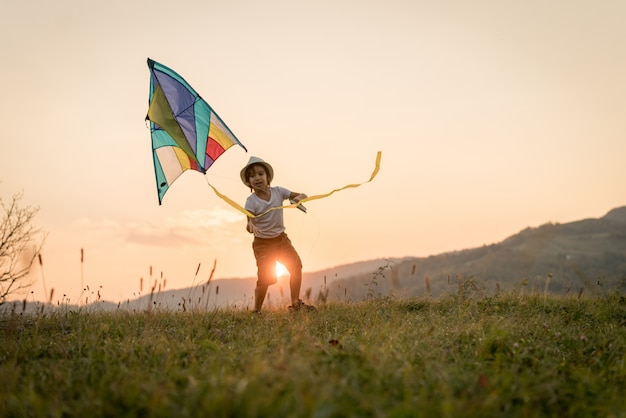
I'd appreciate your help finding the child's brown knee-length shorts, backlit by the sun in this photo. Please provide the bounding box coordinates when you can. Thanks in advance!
[252,233,302,286]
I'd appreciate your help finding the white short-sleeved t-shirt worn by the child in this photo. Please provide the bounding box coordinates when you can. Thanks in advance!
[245,186,291,238]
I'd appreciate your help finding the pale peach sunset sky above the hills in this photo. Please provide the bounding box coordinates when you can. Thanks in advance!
[0,0,626,302]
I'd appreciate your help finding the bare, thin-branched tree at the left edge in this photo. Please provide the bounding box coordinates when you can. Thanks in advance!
[0,193,45,305]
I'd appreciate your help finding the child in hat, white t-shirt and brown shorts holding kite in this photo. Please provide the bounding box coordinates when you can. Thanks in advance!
[240,157,316,313]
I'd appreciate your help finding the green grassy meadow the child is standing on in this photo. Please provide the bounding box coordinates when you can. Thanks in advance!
[0,293,626,417]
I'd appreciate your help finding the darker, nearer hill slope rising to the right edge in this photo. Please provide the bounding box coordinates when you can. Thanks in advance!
[329,206,626,300]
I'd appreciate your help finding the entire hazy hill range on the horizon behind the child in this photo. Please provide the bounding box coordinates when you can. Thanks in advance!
[11,206,626,310]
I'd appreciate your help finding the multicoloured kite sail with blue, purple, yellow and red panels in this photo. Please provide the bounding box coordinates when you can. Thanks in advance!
[146,58,248,205]
